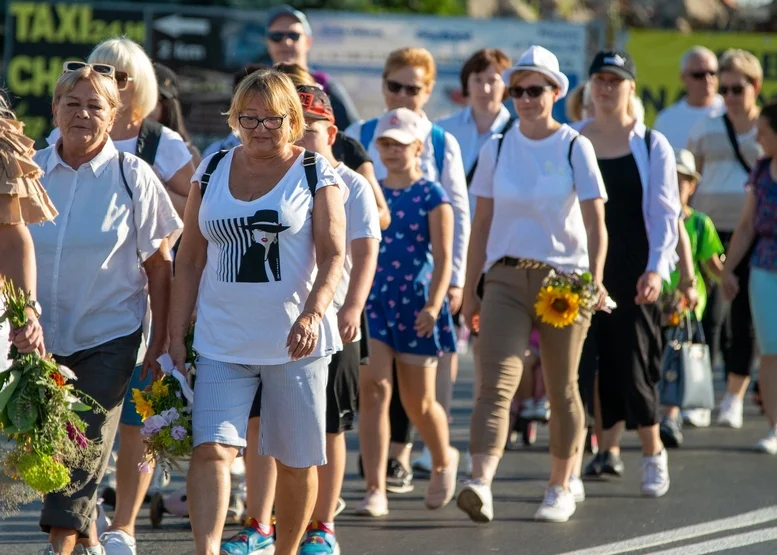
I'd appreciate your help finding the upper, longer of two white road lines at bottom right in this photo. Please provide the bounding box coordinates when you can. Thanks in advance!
[561,505,777,555]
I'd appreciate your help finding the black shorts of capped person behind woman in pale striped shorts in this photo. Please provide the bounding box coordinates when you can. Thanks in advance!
[249,341,361,434]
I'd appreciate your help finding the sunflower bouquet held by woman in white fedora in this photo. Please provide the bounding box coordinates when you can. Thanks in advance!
[534,270,616,328]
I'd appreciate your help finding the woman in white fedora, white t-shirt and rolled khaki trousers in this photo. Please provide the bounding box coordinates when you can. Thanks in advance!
[458,46,607,522]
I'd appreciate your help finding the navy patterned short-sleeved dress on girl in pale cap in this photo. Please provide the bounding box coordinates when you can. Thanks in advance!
[365,179,456,356]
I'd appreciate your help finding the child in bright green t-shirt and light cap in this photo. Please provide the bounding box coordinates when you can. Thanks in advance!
[659,149,723,447]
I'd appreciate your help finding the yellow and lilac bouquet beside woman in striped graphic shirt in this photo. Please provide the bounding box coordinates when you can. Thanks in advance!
[132,327,197,473]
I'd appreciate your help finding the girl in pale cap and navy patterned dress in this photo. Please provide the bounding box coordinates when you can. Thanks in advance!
[357,108,459,516]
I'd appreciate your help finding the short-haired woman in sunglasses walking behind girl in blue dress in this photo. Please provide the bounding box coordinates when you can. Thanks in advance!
[345,48,470,493]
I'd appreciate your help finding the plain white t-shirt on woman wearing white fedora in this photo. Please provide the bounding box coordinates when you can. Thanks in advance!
[470,125,607,272]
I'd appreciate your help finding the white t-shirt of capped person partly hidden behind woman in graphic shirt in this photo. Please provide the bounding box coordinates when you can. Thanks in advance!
[332,163,381,341]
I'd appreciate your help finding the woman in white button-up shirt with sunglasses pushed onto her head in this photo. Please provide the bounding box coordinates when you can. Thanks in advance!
[30,62,182,555]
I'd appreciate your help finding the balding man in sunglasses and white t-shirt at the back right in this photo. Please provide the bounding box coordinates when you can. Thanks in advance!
[653,46,725,148]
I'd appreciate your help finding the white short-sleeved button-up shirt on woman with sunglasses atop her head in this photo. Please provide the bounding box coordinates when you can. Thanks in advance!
[30,139,183,356]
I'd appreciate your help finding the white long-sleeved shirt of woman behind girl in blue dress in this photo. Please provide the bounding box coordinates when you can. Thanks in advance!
[345,115,470,287]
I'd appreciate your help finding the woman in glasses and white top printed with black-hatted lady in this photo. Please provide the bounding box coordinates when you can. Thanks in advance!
[170,70,345,555]
